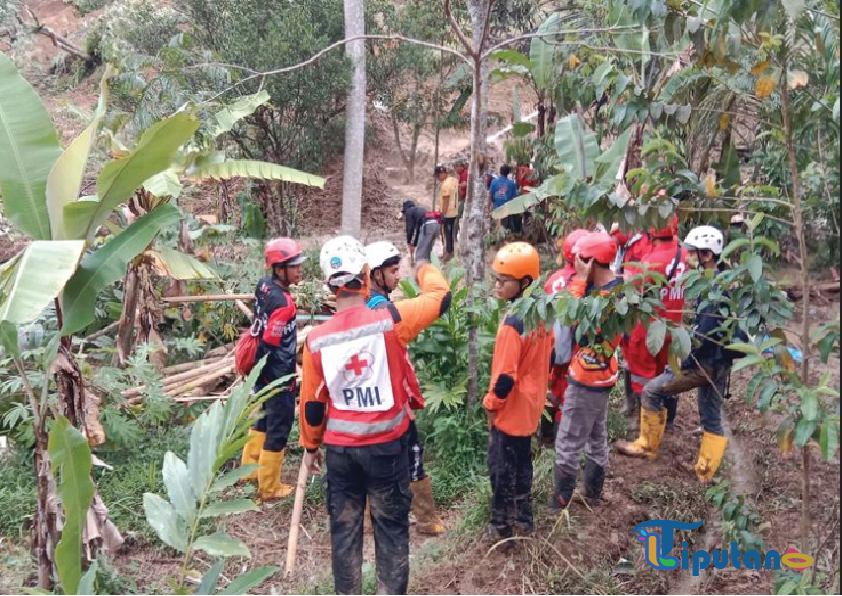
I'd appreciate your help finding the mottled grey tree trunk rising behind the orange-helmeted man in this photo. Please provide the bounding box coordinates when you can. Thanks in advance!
[459,0,491,407]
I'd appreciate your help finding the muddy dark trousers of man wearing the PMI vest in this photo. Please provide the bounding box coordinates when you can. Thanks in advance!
[326,436,412,594]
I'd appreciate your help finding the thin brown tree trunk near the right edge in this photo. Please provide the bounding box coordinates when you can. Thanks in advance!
[781,59,811,553]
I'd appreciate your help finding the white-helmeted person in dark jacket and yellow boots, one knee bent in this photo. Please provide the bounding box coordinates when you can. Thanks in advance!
[617,226,735,482]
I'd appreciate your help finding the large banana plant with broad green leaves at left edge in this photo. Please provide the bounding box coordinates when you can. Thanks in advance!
[0,54,324,588]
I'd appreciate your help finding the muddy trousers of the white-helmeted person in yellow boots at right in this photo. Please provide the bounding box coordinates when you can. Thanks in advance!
[641,365,731,436]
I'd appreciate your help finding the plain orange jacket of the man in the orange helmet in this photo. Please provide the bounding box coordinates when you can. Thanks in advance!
[482,315,553,437]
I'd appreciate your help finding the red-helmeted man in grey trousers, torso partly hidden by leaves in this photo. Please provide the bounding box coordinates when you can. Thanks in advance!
[553,233,622,509]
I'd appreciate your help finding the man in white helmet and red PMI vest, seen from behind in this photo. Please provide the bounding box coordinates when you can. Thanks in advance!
[299,236,450,594]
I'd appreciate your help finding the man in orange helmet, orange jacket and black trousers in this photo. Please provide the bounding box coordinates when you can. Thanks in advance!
[482,242,553,538]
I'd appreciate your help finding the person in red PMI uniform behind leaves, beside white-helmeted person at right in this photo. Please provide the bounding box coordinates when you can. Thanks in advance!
[622,217,687,439]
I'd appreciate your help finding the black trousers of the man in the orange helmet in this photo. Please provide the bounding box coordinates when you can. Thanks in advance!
[488,428,533,538]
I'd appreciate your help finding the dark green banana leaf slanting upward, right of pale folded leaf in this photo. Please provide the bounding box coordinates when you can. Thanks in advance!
[61,203,181,335]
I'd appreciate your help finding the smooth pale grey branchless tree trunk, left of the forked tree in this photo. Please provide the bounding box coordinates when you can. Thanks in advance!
[342,0,366,238]
